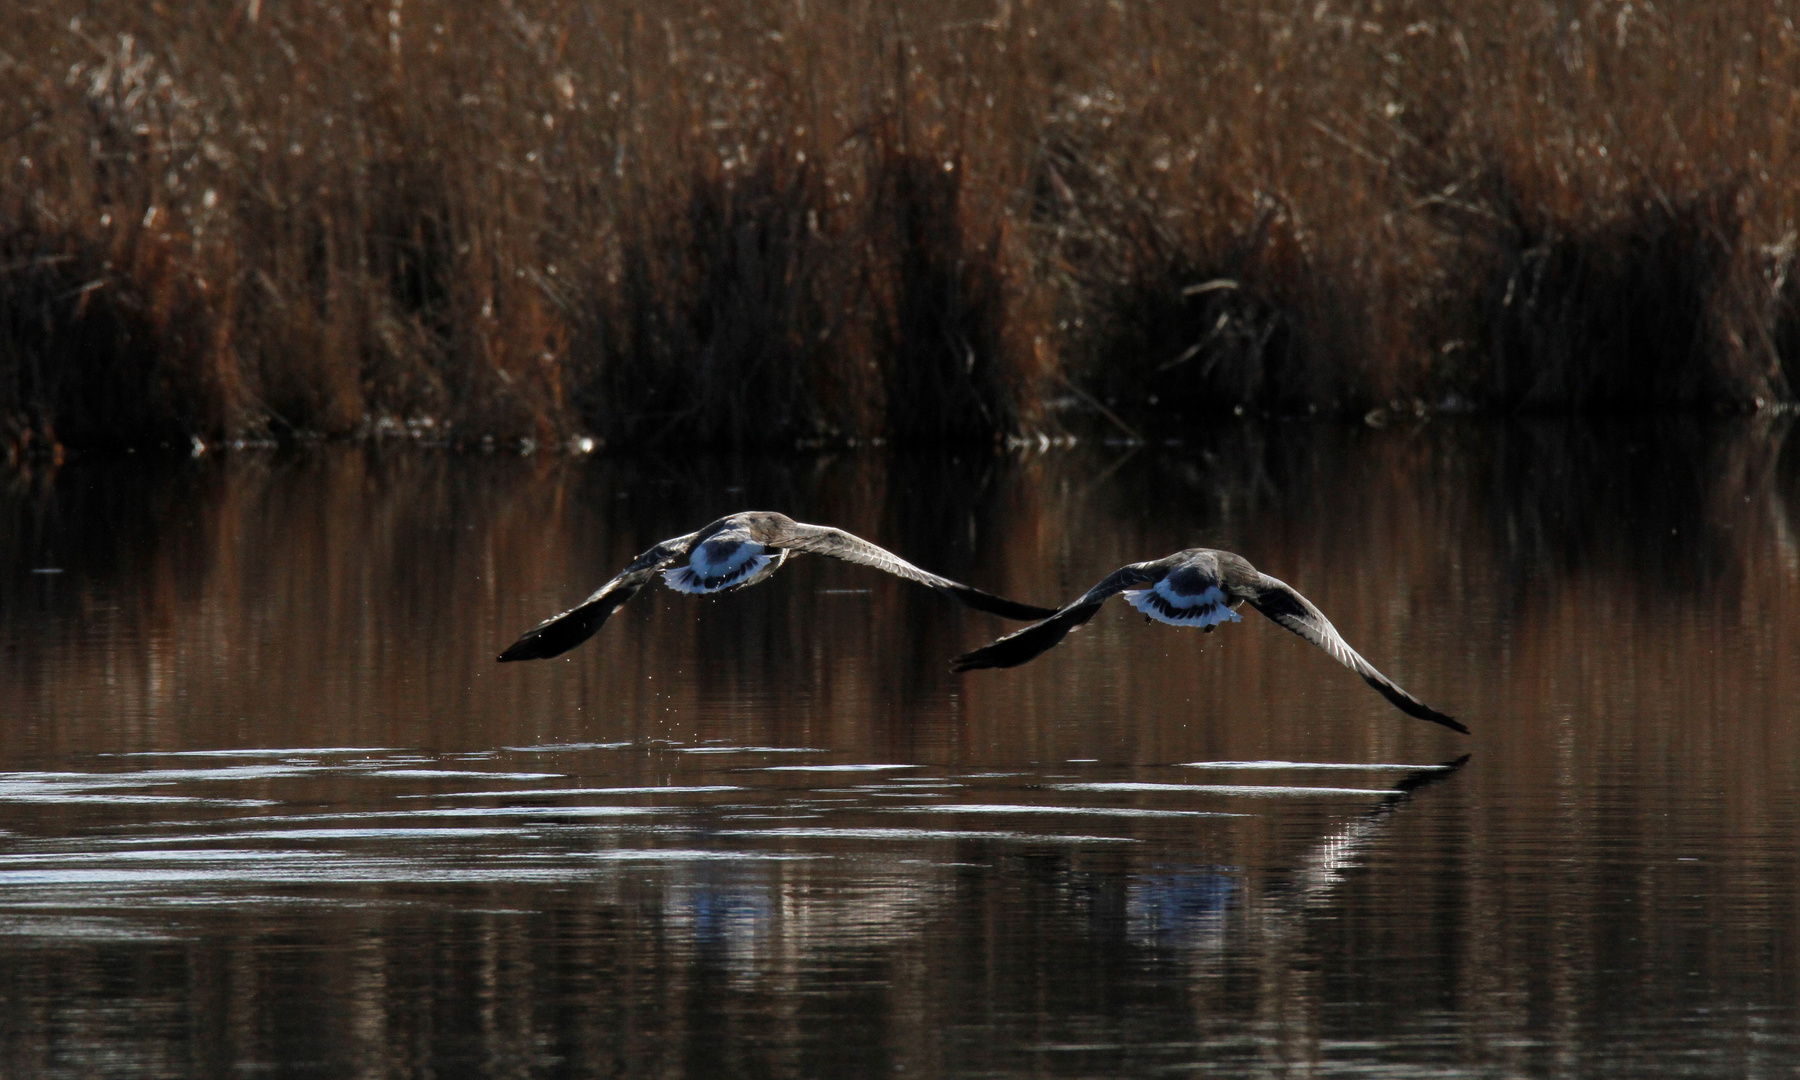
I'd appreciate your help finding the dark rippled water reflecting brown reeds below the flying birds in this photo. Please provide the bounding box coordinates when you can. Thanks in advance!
[0,418,1800,1076]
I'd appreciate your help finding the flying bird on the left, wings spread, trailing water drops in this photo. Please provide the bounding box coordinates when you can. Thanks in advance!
[500,509,1057,661]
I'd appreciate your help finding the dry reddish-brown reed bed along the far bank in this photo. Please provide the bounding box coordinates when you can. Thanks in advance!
[0,0,1800,455]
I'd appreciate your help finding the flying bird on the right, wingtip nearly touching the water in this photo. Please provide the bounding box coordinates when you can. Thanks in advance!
[950,547,1469,734]
